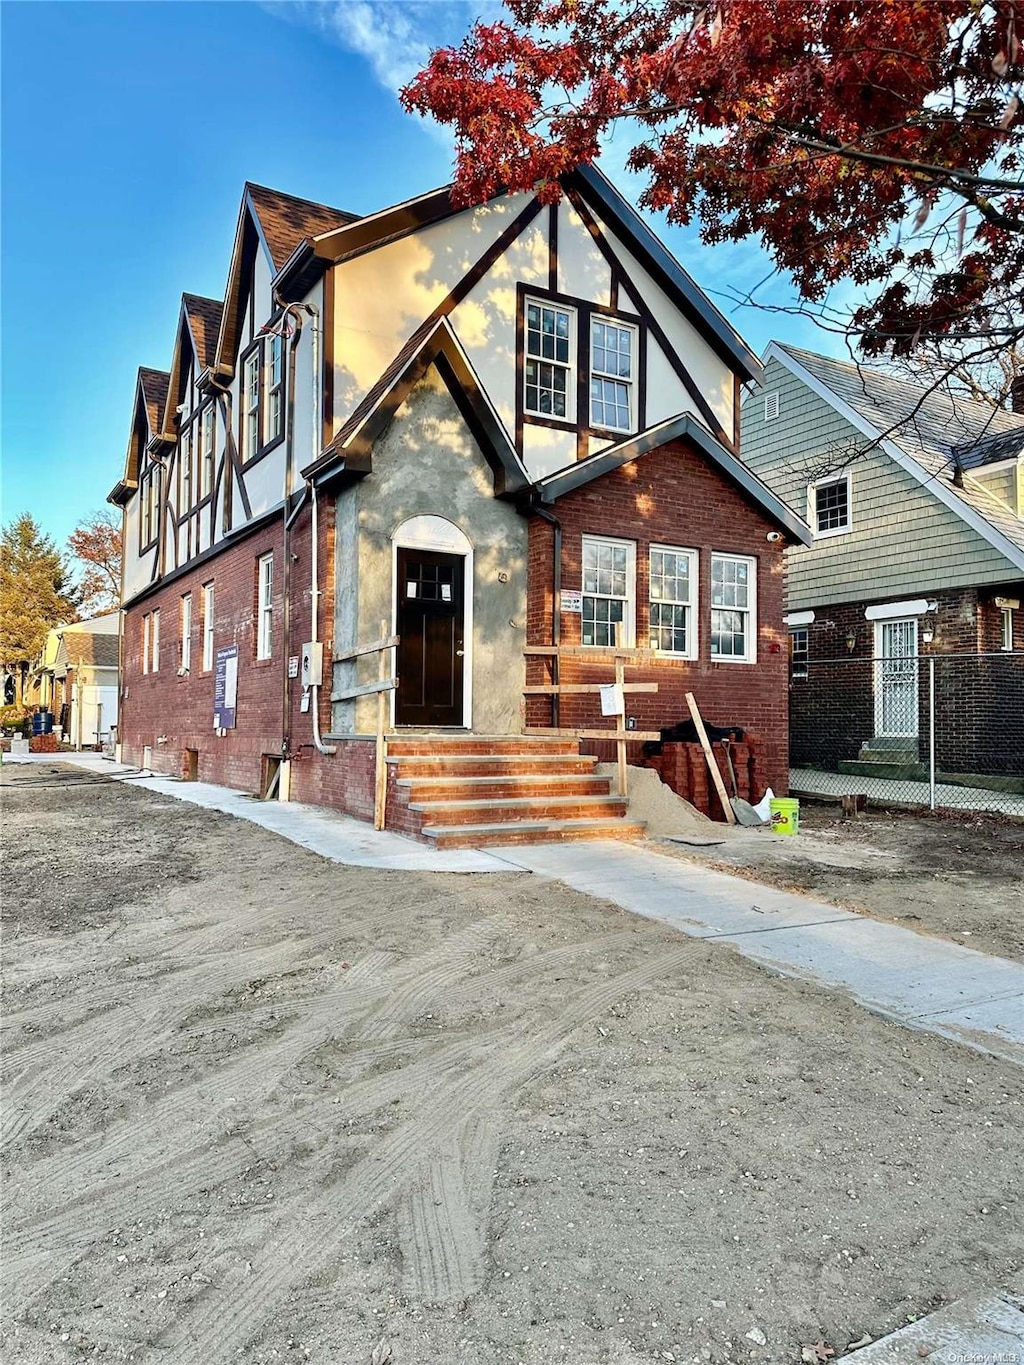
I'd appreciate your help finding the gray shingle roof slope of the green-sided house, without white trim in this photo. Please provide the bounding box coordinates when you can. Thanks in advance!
[774,341,1024,550]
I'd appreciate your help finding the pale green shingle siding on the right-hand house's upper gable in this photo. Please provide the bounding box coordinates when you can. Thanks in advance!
[740,359,1020,610]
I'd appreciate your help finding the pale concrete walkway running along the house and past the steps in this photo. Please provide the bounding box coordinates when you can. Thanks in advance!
[4,753,1024,1065]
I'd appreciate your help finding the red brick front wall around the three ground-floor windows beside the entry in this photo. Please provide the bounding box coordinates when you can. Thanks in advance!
[527,442,789,794]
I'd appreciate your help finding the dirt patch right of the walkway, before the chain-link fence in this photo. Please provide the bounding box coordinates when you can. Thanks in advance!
[662,801,1024,960]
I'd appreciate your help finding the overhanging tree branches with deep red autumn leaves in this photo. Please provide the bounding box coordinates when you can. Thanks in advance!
[401,0,1024,355]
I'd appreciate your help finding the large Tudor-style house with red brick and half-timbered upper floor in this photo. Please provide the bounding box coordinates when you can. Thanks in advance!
[111,171,808,839]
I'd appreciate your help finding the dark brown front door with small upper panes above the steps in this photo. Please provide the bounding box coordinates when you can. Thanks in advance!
[395,550,466,725]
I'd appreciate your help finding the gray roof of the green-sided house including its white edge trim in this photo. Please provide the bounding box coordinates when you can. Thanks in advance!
[763,341,1024,569]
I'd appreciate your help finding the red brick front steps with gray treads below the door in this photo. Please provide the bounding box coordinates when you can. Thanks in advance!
[388,734,644,849]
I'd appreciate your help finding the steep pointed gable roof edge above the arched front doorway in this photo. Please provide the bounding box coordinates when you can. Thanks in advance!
[302,318,530,497]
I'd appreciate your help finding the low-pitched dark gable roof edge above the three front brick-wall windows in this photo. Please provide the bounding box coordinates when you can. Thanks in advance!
[535,412,814,545]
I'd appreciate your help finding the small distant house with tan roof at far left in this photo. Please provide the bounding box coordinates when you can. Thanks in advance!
[33,612,119,749]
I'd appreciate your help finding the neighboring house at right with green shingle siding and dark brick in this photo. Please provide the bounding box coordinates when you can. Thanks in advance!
[743,343,1024,777]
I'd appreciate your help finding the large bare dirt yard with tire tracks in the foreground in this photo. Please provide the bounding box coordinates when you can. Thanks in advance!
[0,764,1024,1365]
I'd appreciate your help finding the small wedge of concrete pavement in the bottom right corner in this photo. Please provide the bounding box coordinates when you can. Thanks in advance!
[842,1291,1024,1365]
